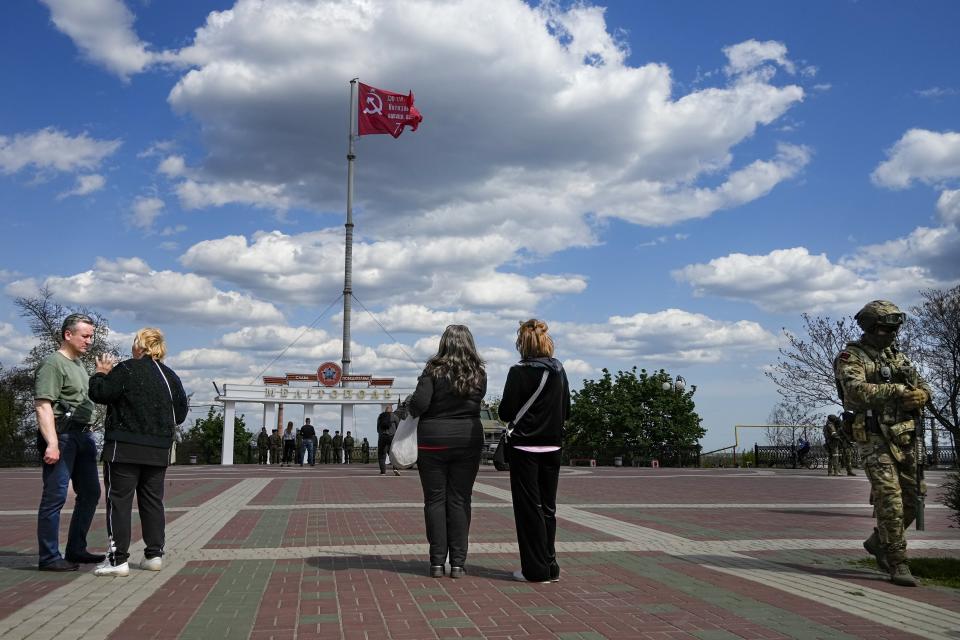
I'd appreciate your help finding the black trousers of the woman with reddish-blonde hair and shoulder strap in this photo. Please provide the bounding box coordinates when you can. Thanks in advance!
[509,447,560,582]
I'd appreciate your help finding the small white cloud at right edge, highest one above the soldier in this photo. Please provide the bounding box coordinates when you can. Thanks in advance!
[870,129,960,189]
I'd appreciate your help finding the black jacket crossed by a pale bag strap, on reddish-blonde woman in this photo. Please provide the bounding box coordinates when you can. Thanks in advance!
[498,358,570,447]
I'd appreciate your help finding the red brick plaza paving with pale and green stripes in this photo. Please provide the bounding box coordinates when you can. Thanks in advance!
[0,465,960,640]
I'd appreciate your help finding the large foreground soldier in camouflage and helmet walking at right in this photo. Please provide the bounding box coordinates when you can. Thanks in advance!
[834,300,930,587]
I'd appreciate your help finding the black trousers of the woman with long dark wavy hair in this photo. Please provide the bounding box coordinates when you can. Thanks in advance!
[417,447,480,567]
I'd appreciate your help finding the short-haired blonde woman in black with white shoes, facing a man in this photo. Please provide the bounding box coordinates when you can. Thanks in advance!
[90,328,188,577]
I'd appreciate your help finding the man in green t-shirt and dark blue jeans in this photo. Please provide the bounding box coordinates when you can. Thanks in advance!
[33,313,106,571]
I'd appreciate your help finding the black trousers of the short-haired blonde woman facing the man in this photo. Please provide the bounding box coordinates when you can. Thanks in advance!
[103,462,167,565]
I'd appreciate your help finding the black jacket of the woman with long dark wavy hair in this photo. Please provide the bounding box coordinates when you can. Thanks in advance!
[408,374,487,449]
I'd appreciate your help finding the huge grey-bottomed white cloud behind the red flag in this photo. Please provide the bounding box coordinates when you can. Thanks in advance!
[154,0,808,241]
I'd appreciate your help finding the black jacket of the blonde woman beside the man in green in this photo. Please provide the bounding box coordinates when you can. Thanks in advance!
[90,356,189,449]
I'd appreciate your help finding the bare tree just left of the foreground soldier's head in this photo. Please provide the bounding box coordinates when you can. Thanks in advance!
[765,313,860,408]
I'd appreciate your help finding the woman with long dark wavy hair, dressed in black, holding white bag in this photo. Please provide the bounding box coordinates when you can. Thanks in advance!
[407,324,487,578]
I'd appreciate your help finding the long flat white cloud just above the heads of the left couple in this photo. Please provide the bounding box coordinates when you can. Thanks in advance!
[6,258,282,325]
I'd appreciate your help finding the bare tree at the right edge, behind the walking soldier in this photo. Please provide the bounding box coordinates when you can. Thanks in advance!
[911,286,960,453]
